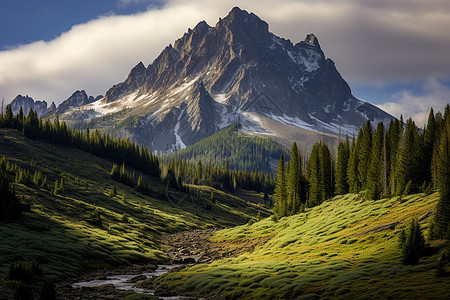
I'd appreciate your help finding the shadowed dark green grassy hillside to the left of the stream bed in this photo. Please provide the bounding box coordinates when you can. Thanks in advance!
[0,129,259,278]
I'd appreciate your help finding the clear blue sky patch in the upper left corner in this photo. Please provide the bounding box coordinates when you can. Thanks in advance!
[0,0,161,50]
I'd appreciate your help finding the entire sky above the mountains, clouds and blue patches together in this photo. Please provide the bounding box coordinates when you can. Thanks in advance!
[0,0,450,124]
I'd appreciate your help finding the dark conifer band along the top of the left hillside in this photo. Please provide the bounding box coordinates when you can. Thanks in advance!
[0,104,272,200]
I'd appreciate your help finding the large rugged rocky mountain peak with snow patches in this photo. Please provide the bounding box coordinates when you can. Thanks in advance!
[62,7,392,152]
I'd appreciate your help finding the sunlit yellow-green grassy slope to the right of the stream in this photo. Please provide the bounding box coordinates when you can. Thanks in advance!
[157,193,450,299]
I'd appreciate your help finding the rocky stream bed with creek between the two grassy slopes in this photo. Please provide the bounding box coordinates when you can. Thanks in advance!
[57,229,253,300]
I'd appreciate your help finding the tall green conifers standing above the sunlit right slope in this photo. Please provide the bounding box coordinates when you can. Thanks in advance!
[274,105,450,236]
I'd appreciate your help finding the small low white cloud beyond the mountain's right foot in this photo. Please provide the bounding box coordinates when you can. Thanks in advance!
[377,78,450,127]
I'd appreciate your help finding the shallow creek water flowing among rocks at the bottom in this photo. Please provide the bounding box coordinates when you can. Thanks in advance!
[72,265,186,300]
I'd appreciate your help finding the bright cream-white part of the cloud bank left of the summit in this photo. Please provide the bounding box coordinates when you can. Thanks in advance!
[0,4,218,102]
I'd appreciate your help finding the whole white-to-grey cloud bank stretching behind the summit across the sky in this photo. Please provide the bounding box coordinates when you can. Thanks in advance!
[0,0,450,120]
